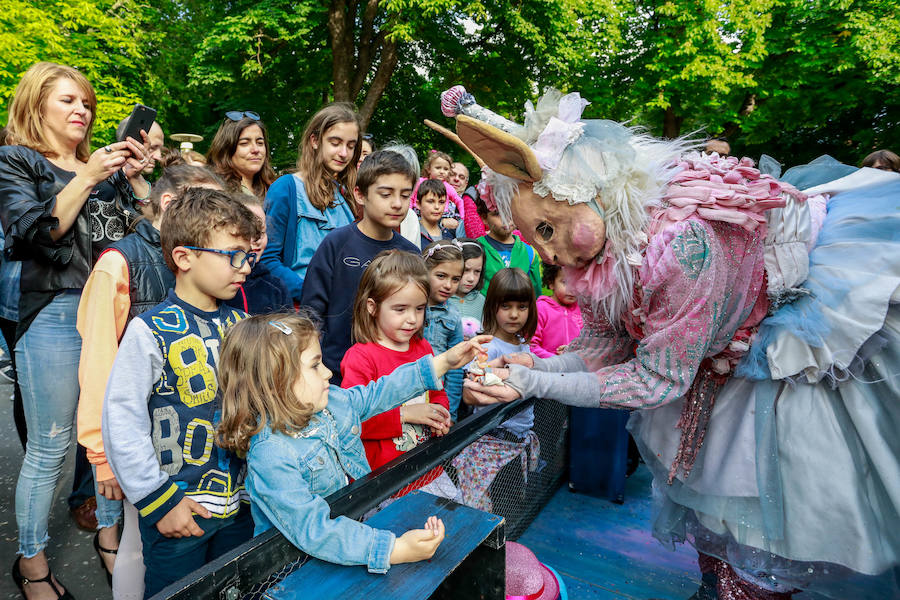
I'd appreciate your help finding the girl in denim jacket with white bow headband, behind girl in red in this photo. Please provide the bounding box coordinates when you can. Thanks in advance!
[422,240,464,423]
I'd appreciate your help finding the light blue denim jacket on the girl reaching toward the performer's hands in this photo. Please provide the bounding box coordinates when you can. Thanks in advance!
[245,356,441,573]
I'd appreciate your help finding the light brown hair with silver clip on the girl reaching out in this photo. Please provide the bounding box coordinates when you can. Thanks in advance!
[217,313,319,456]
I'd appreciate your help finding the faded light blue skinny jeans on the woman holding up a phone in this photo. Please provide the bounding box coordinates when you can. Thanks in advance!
[16,293,81,558]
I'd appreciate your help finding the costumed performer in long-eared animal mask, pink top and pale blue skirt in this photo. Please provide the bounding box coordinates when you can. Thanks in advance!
[442,86,900,600]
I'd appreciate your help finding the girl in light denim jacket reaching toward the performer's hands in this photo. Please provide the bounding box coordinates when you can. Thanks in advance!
[219,313,490,573]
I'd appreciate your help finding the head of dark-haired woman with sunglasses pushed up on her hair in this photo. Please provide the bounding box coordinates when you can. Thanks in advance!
[206,110,275,198]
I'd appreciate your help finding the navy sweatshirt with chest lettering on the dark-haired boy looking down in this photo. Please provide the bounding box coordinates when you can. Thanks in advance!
[300,223,419,386]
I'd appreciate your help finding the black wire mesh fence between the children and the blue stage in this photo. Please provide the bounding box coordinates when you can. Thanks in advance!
[160,400,569,600]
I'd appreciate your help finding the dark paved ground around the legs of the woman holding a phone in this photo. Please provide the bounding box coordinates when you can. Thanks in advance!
[0,379,112,600]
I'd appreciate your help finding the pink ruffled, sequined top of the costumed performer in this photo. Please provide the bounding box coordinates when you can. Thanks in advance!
[510,155,802,480]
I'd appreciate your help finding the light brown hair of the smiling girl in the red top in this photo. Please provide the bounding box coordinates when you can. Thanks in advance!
[352,250,430,344]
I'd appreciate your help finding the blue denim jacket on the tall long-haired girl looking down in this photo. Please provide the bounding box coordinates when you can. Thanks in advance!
[260,173,353,302]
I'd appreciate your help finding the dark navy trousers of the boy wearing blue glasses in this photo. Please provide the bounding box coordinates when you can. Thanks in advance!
[139,505,253,598]
